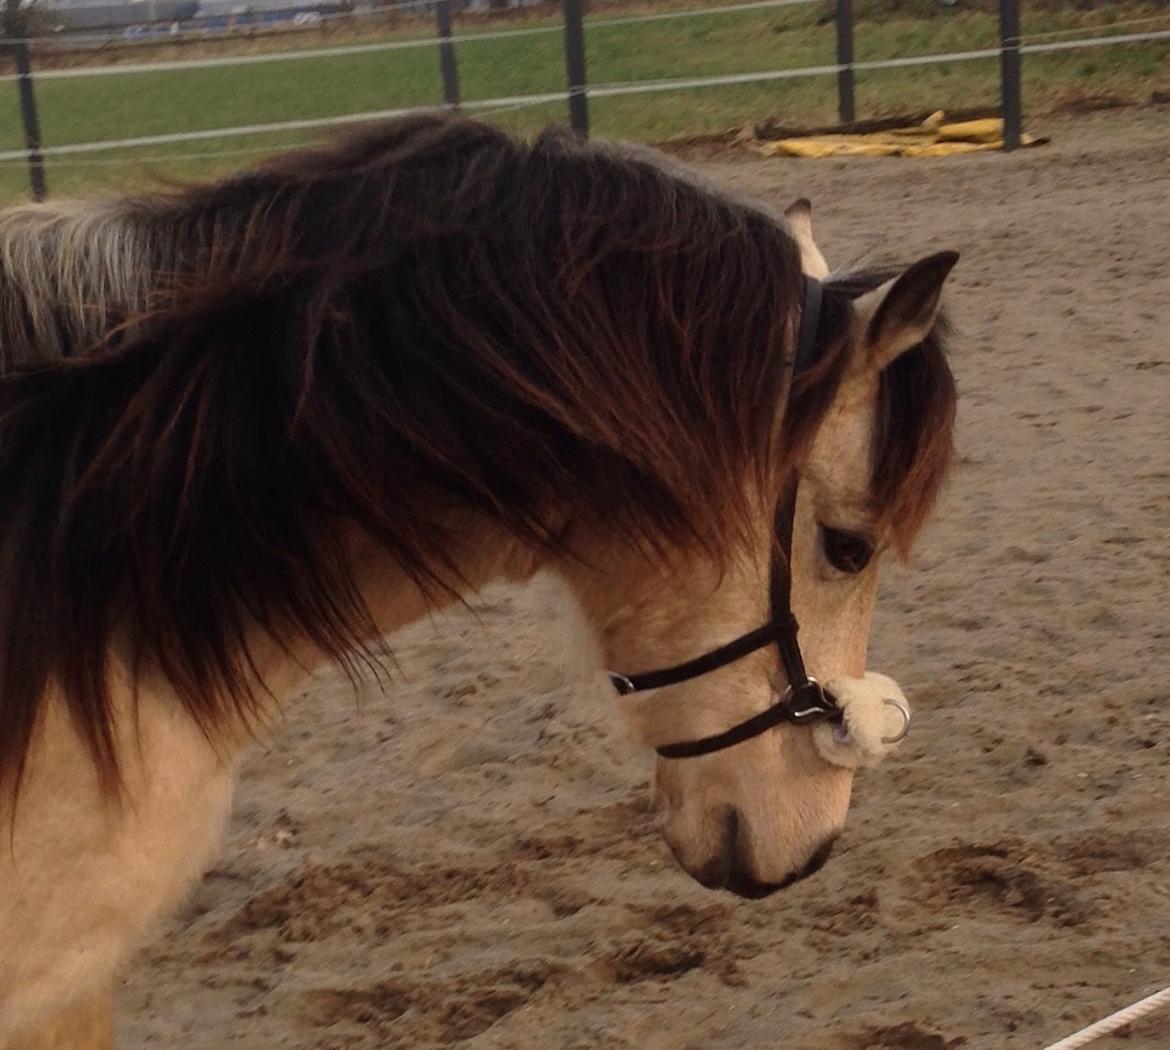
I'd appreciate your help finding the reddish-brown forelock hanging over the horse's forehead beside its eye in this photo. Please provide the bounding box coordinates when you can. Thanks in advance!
[825,267,958,557]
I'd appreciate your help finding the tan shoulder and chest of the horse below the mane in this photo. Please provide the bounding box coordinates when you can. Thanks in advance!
[0,689,238,1046]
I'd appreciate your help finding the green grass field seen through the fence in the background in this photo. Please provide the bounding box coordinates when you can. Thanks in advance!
[0,0,1170,199]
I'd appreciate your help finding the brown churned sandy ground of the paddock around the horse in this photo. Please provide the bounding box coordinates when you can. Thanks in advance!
[121,108,1170,1050]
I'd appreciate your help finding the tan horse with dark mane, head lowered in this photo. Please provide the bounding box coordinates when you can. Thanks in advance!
[0,115,956,1050]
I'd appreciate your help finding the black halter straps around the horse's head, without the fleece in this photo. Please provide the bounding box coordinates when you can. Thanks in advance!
[610,277,841,759]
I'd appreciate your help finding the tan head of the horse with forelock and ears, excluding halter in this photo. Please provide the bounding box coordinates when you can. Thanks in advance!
[554,201,957,897]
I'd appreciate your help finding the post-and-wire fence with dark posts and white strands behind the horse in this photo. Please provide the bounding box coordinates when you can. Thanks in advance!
[0,0,1170,199]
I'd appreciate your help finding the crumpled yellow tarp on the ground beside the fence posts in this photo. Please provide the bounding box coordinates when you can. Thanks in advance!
[755,110,1040,159]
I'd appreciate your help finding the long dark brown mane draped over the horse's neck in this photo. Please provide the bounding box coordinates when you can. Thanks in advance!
[0,116,844,794]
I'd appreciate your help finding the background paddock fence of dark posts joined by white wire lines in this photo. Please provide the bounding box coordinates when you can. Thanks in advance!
[0,0,1170,200]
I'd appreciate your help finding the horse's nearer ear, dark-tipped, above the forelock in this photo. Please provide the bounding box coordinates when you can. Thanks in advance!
[853,252,958,372]
